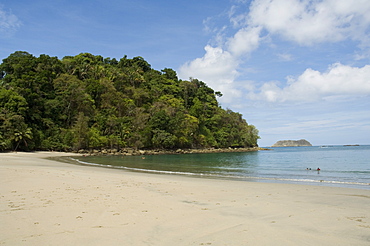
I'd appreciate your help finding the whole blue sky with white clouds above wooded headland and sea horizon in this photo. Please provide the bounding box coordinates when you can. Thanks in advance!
[0,0,370,146]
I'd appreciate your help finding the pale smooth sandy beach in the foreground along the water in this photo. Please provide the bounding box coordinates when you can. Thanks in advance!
[0,152,370,246]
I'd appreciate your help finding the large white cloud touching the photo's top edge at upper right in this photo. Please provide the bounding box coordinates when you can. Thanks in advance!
[249,0,370,45]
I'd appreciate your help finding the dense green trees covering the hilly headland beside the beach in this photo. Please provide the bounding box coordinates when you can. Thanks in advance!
[0,51,259,150]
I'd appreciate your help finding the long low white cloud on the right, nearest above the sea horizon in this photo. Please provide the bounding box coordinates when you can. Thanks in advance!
[249,63,370,102]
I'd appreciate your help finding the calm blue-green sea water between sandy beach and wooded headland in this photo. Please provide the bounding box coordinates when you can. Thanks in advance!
[67,145,370,190]
